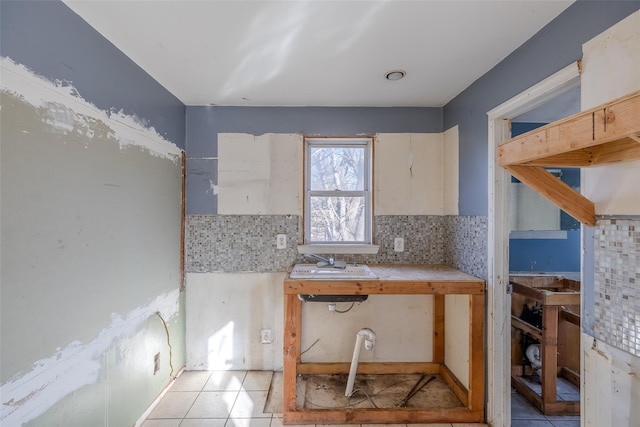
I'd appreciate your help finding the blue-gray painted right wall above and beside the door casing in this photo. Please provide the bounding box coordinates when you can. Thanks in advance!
[444,1,640,215]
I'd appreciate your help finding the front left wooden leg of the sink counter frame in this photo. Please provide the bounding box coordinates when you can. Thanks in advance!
[282,295,302,416]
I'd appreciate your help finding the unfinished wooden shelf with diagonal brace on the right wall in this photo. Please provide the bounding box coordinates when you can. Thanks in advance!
[498,91,640,226]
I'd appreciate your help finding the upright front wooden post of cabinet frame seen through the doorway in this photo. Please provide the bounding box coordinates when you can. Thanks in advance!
[541,305,558,403]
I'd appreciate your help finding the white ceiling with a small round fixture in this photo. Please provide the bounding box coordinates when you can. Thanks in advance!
[65,0,572,107]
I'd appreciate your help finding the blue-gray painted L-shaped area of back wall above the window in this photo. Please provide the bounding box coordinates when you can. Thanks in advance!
[186,106,443,215]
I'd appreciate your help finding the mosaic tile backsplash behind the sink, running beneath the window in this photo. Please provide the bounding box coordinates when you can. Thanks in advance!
[185,215,487,278]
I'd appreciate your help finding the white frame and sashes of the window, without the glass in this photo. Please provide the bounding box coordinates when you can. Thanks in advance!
[304,137,373,246]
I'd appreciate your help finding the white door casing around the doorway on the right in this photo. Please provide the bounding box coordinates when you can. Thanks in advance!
[487,62,580,426]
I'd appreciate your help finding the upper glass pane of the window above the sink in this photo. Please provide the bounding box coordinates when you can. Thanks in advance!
[310,146,366,191]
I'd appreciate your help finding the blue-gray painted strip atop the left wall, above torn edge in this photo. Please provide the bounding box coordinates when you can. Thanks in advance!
[0,0,185,149]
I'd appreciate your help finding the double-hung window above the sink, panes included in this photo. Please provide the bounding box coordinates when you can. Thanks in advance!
[304,138,373,244]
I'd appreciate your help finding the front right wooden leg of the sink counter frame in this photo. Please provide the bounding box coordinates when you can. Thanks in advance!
[469,295,485,411]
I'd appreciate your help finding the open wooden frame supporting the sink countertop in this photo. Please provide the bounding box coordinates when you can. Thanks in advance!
[283,265,485,424]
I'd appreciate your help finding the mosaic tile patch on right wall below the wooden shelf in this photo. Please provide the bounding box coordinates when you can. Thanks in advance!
[594,218,640,357]
